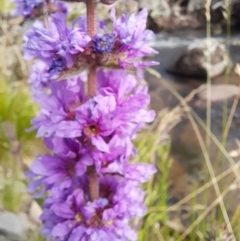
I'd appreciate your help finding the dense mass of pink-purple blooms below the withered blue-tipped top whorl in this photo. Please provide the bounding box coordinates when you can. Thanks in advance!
[28,70,155,241]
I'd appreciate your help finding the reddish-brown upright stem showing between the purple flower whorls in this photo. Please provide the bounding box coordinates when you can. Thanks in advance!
[85,0,99,201]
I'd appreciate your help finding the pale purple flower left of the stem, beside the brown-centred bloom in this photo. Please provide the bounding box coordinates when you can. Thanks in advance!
[30,77,85,137]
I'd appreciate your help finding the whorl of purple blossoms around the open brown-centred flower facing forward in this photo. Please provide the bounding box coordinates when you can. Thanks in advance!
[32,71,155,149]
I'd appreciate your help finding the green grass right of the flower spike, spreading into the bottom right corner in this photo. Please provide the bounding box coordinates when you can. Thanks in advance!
[135,129,240,241]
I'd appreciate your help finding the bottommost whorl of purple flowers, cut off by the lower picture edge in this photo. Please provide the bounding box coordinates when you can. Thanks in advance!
[41,176,148,241]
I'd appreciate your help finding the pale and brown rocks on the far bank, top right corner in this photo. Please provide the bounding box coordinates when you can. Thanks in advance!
[136,0,240,32]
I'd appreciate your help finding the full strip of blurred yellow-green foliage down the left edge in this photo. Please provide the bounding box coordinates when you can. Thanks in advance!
[0,78,36,215]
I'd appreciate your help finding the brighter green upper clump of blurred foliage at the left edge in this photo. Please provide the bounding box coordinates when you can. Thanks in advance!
[0,78,36,162]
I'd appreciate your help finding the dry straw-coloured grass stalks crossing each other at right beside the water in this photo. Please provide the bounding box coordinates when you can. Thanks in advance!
[146,66,240,241]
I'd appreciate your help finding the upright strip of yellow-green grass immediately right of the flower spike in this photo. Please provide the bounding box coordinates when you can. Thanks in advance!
[136,133,172,241]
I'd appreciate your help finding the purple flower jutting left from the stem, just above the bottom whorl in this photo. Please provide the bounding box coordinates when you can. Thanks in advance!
[27,137,93,196]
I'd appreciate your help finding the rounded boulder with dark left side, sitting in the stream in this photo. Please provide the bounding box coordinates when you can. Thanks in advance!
[168,39,230,78]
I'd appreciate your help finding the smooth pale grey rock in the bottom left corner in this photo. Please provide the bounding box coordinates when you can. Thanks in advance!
[0,212,27,241]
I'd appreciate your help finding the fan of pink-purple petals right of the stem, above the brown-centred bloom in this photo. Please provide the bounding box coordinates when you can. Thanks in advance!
[98,70,155,136]
